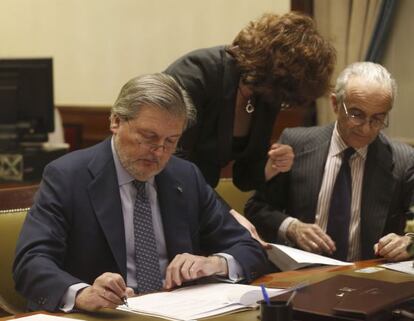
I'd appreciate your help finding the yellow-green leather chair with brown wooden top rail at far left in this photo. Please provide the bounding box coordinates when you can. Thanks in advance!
[0,185,38,314]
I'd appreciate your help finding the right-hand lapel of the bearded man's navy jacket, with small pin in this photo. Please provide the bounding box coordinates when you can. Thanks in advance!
[155,162,193,261]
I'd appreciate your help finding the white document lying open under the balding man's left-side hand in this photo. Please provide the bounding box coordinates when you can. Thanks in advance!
[267,244,353,271]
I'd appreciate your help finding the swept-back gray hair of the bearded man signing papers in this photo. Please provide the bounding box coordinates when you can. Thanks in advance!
[111,73,196,126]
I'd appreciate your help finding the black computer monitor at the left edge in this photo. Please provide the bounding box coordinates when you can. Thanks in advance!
[0,58,54,149]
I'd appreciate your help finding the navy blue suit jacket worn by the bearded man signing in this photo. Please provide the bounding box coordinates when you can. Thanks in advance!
[14,139,267,310]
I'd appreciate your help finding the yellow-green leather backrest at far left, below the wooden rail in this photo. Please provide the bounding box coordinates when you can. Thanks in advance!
[0,209,28,314]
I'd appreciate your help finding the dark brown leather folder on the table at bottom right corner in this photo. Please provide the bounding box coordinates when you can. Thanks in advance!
[272,275,414,321]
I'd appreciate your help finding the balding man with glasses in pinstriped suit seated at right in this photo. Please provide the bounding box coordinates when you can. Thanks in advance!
[246,62,414,261]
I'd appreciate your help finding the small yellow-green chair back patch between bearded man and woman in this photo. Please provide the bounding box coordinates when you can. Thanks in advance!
[216,178,253,214]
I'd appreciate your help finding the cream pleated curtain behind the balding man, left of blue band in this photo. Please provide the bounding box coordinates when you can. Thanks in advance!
[314,0,381,125]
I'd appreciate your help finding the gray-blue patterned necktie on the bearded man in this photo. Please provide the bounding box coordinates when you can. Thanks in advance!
[133,181,162,293]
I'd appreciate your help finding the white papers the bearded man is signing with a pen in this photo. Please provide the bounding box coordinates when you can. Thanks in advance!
[118,283,286,321]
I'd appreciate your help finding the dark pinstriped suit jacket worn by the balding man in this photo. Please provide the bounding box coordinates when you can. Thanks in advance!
[246,125,414,259]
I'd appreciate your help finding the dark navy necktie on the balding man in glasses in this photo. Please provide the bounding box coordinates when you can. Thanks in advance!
[327,147,355,261]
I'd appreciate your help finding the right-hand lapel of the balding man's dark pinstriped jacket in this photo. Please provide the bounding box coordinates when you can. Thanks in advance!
[361,138,396,257]
